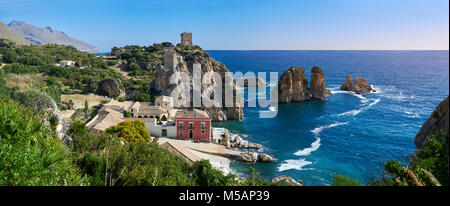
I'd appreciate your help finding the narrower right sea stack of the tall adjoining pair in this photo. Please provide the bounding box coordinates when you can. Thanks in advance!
[309,66,331,100]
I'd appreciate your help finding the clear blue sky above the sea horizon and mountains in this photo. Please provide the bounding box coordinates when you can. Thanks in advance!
[0,0,449,51]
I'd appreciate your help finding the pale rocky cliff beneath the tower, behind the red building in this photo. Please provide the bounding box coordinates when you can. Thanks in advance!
[151,47,244,121]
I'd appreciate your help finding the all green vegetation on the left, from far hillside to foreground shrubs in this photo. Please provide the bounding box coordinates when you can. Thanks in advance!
[0,39,286,186]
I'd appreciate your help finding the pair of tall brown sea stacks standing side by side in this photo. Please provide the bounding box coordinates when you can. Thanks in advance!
[277,66,331,103]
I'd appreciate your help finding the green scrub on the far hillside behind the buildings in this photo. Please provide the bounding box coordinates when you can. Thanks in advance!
[0,39,156,102]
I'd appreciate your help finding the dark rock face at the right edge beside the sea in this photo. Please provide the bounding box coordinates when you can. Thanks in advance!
[414,97,449,151]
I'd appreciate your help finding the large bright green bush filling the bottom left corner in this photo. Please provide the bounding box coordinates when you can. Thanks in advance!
[0,100,87,185]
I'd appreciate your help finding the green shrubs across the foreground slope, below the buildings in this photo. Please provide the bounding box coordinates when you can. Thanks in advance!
[0,96,269,186]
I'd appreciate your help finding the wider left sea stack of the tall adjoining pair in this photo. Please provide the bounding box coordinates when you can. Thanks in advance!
[277,66,312,103]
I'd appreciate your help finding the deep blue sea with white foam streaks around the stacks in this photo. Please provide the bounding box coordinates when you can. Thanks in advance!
[208,50,449,185]
